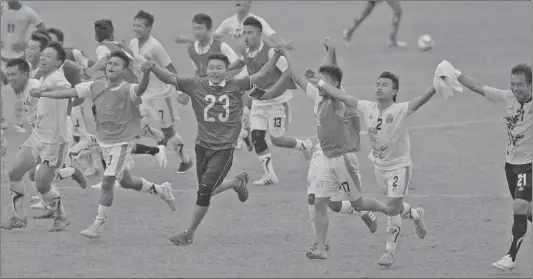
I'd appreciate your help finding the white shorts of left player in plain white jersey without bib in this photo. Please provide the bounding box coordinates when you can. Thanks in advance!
[20,135,69,168]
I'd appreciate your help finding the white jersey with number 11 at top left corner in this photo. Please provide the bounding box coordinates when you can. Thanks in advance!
[0,4,42,59]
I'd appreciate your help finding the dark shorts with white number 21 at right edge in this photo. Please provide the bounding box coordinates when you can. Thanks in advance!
[505,163,531,202]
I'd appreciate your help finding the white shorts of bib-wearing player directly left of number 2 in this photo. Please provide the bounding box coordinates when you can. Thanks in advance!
[307,152,362,201]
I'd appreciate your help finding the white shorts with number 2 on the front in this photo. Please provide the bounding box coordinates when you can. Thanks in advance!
[374,166,412,198]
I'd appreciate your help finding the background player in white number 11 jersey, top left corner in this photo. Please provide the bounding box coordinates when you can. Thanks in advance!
[0,0,46,133]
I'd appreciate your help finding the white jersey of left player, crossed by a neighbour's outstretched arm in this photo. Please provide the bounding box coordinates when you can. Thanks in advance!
[32,70,70,143]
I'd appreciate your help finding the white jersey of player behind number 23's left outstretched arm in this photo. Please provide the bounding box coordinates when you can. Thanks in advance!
[129,36,173,98]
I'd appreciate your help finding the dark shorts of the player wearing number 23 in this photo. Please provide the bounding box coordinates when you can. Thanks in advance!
[194,145,235,190]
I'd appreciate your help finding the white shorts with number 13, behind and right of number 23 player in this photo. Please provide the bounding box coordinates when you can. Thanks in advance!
[250,103,291,138]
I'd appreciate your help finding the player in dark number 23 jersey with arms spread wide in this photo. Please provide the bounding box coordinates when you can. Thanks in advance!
[145,47,281,245]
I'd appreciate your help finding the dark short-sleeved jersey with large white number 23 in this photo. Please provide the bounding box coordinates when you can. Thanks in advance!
[177,77,250,150]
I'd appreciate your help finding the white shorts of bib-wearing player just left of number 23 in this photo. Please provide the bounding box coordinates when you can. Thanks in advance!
[100,143,135,181]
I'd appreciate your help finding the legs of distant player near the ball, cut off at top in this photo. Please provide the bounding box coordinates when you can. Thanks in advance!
[342,0,407,47]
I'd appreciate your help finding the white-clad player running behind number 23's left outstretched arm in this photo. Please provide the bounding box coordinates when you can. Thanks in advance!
[129,10,192,173]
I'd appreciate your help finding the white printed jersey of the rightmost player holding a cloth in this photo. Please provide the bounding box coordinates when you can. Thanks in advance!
[483,86,533,165]
